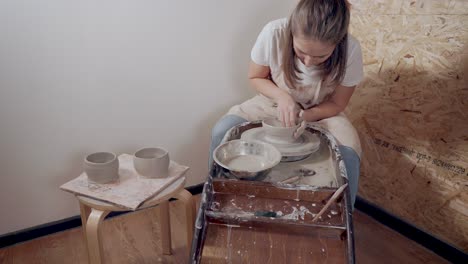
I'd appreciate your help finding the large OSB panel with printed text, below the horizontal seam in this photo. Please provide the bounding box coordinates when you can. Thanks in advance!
[347,12,468,251]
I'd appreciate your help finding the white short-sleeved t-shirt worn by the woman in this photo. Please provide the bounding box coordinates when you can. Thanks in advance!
[251,18,364,109]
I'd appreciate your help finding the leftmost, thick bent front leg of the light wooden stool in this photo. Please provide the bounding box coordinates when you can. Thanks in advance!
[86,208,109,264]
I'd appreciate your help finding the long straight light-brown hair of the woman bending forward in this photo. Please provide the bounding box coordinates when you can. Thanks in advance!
[282,0,350,89]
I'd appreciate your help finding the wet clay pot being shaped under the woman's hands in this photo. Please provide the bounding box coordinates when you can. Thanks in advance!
[262,118,304,143]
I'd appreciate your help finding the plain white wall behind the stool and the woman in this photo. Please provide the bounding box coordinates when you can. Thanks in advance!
[0,0,294,234]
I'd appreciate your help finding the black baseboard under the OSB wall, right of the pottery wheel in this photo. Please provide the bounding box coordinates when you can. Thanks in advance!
[354,196,468,263]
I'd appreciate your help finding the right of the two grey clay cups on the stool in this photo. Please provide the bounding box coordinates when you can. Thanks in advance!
[133,148,170,178]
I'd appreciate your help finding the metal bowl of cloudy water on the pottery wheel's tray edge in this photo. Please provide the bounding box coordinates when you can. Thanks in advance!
[213,140,281,180]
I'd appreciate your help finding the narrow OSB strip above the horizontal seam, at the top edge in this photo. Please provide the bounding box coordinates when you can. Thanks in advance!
[349,0,468,15]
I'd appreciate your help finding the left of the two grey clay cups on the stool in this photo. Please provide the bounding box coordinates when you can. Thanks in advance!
[83,152,119,183]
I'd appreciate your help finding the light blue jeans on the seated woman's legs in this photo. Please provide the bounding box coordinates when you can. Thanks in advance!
[208,115,361,208]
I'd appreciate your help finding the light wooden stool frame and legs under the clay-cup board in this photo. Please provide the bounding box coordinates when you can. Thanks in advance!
[76,177,195,264]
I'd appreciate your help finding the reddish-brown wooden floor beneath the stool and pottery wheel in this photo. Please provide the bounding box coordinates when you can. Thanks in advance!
[0,197,448,264]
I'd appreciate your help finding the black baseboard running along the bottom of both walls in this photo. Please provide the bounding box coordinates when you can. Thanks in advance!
[0,183,468,263]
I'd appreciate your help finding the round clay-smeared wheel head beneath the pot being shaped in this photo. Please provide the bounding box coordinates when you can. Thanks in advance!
[241,127,320,157]
